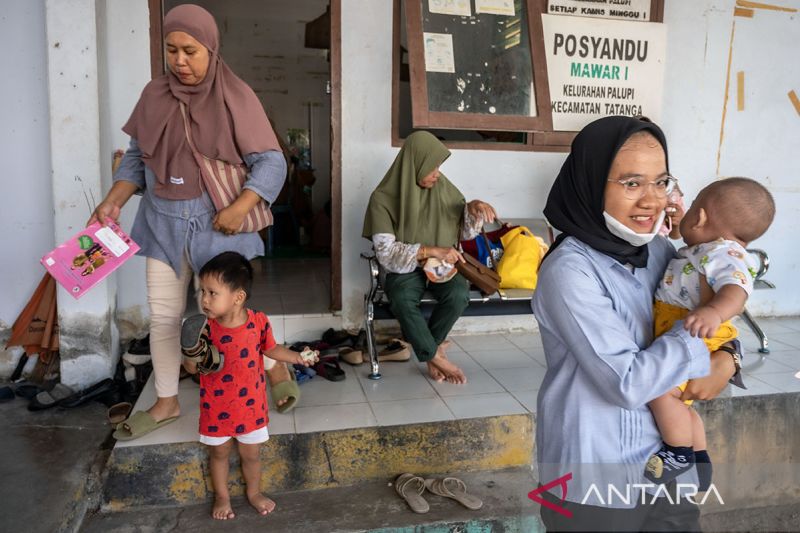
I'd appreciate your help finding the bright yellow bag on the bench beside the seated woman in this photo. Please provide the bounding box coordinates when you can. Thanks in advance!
[497,226,547,289]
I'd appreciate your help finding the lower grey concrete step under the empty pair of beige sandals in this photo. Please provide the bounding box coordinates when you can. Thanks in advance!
[81,467,544,533]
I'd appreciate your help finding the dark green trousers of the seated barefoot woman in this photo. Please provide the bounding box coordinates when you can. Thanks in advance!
[384,269,469,363]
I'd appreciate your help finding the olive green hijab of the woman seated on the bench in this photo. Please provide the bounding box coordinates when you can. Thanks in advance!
[361,131,465,246]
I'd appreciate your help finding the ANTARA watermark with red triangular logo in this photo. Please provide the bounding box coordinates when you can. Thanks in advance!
[528,472,725,518]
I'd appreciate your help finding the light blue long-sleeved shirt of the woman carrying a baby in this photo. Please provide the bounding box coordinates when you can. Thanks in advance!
[532,237,710,508]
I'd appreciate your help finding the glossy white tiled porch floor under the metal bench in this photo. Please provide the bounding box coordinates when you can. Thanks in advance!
[118,317,800,446]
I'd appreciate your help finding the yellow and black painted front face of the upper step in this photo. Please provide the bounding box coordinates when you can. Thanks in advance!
[102,414,534,511]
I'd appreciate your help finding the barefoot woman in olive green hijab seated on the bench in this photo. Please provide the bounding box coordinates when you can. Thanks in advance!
[362,131,496,384]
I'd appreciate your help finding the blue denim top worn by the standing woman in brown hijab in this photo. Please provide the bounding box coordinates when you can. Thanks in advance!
[114,139,286,274]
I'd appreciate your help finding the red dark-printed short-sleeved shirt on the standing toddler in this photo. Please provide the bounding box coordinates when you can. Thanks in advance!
[200,309,276,437]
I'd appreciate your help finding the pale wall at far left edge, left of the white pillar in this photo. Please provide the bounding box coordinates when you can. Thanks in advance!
[0,0,55,330]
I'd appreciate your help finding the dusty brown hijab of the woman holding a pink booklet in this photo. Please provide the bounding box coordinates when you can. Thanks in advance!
[122,4,280,200]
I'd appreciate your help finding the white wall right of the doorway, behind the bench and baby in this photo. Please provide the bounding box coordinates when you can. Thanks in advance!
[342,0,800,327]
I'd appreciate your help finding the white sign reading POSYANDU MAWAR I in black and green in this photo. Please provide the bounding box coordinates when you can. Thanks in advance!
[542,15,667,131]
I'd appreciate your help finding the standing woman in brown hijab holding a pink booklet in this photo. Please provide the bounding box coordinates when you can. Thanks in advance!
[89,4,299,440]
